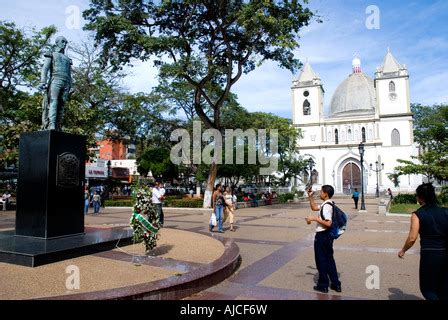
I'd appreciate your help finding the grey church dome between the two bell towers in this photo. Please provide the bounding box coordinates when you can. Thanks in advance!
[330,58,376,117]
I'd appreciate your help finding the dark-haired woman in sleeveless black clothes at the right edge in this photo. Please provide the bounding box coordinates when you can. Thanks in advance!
[398,183,448,300]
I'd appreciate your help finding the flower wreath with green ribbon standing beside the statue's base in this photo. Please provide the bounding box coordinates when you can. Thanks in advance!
[130,187,161,252]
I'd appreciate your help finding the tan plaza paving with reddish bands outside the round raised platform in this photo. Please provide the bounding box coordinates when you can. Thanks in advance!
[0,198,423,300]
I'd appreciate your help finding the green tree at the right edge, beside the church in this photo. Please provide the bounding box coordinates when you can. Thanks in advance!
[395,104,448,181]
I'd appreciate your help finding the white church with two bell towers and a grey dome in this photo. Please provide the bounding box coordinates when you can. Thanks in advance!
[292,50,422,194]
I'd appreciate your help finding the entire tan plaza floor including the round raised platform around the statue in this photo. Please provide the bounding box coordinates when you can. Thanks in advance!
[0,197,423,300]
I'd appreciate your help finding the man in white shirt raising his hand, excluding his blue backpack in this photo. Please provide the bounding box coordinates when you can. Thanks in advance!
[306,185,342,293]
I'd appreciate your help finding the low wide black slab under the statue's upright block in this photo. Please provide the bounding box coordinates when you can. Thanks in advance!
[0,229,132,267]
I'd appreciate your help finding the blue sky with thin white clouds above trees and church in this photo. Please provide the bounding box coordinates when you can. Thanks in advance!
[0,0,448,118]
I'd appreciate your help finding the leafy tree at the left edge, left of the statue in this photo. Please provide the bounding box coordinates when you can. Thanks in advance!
[0,21,56,167]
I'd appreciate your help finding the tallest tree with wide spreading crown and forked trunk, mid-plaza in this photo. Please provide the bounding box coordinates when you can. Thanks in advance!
[84,0,313,207]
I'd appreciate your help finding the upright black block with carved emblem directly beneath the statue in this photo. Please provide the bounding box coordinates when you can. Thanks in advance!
[16,130,86,239]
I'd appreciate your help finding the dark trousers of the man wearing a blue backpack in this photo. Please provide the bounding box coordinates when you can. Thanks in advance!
[314,231,341,288]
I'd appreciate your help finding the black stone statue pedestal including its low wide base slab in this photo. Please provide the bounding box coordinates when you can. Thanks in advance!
[0,131,133,267]
